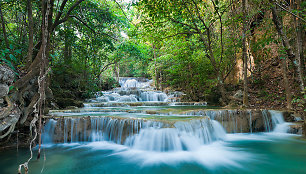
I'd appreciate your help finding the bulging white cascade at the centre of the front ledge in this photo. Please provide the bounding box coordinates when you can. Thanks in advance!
[125,119,226,152]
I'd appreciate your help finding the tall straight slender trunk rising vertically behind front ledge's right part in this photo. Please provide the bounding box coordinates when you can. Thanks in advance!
[242,0,249,106]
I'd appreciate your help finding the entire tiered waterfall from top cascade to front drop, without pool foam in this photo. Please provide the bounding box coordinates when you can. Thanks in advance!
[42,78,288,158]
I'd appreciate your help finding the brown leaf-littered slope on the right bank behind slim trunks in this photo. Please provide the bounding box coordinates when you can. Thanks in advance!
[227,58,305,118]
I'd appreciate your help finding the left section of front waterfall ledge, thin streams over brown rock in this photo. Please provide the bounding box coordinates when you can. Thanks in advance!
[43,117,164,144]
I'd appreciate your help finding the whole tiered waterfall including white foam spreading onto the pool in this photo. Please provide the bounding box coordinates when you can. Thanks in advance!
[38,78,289,173]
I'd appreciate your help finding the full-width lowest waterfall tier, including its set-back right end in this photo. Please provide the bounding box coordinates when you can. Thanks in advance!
[43,110,288,152]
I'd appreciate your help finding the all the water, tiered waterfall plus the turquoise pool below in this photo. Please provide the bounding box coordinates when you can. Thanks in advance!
[0,78,306,174]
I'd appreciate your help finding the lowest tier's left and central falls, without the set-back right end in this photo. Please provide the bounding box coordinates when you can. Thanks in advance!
[43,117,226,149]
